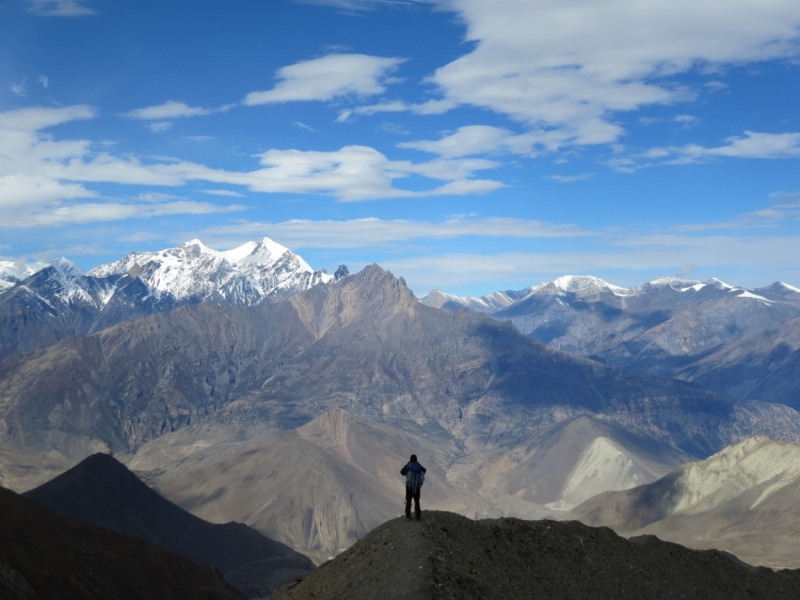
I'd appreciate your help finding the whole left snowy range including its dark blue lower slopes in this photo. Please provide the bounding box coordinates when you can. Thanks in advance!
[0,238,340,358]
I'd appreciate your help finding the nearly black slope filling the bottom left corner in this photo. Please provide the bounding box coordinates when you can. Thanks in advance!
[0,488,242,600]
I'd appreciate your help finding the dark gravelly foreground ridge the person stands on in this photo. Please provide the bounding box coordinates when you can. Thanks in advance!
[270,511,800,600]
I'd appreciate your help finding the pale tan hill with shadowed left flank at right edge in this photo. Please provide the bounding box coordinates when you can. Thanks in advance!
[564,437,800,568]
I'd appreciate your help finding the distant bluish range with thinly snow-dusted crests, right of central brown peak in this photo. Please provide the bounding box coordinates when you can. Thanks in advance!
[422,276,800,409]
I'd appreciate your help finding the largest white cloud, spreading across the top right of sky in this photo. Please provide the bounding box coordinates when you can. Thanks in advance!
[339,0,800,144]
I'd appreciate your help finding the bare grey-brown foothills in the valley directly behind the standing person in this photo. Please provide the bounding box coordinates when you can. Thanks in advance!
[153,409,687,562]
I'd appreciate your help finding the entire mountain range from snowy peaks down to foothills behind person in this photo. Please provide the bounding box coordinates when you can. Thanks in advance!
[0,239,800,562]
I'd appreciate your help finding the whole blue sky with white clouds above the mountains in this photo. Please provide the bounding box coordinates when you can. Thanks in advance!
[0,0,800,295]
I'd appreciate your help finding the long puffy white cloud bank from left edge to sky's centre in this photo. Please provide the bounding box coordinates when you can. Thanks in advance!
[0,106,502,226]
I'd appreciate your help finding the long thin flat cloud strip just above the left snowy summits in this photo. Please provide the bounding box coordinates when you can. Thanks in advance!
[198,217,594,248]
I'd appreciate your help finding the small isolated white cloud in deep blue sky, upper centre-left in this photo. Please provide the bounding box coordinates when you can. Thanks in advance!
[244,54,404,106]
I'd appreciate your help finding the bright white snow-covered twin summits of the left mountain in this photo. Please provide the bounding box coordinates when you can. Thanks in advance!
[88,238,334,305]
